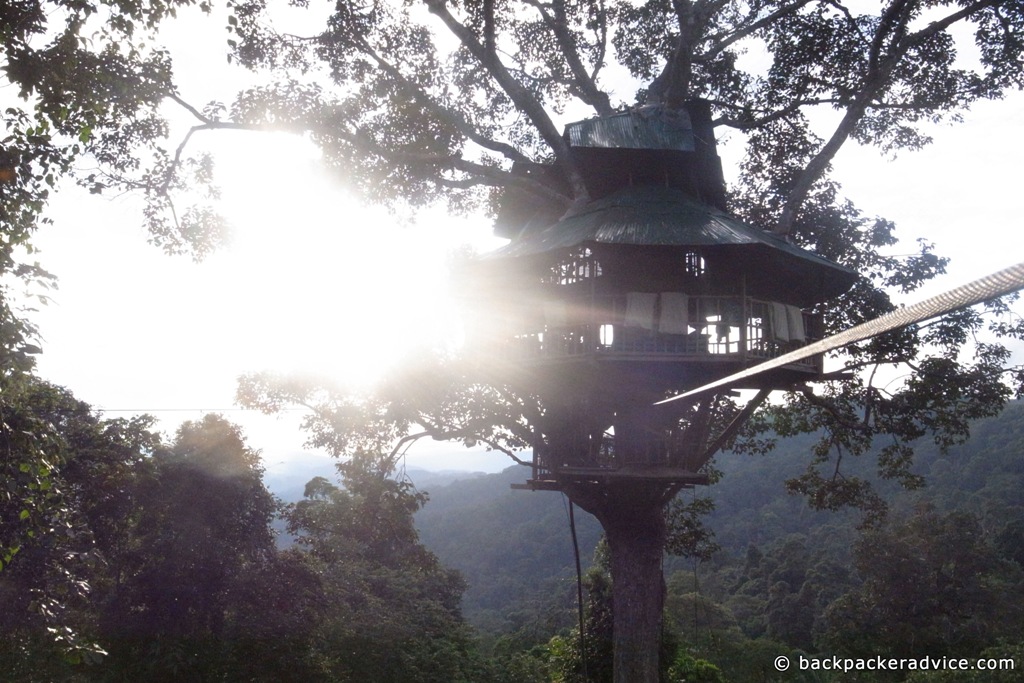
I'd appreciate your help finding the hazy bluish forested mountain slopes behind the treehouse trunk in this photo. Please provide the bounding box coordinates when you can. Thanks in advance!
[416,401,1024,633]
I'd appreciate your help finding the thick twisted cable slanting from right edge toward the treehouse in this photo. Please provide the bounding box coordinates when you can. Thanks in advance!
[654,262,1024,405]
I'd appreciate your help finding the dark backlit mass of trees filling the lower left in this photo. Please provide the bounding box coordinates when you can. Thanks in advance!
[0,397,495,683]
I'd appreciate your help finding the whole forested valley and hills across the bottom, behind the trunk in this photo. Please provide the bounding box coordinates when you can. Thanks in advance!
[0,380,1024,683]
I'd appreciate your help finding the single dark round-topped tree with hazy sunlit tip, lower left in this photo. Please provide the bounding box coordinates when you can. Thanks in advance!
[97,415,275,680]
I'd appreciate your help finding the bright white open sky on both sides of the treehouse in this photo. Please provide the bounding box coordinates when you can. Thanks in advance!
[16,9,1024,471]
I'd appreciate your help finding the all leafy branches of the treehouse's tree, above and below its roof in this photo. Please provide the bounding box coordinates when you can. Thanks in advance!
[228,0,1024,532]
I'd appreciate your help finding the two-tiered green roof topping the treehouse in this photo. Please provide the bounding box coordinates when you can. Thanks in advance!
[492,100,857,305]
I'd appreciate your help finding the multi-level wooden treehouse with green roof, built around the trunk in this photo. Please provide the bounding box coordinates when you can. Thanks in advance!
[471,102,856,488]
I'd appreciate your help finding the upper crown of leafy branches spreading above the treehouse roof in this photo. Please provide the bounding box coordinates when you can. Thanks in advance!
[216,0,1022,227]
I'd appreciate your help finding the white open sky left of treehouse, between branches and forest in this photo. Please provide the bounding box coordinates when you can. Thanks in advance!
[27,133,509,470]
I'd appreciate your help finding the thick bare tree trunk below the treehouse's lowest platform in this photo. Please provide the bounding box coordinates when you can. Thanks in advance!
[585,484,666,683]
